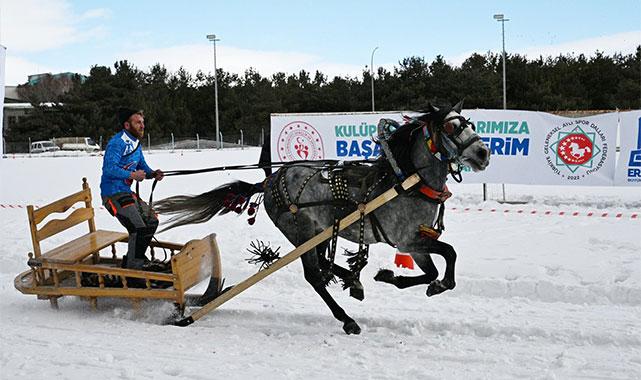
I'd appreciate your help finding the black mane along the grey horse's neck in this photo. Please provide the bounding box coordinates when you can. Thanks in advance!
[376,106,452,173]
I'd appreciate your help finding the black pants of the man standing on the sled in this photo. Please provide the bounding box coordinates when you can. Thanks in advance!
[102,192,158,269]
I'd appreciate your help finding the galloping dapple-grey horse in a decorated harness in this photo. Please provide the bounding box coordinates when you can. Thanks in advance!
[155,102,490,334]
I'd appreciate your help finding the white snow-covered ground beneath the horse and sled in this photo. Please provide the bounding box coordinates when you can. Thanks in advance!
[0,149,641,379]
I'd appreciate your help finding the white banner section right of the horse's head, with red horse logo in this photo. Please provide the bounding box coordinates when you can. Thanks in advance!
[462,110,617,186]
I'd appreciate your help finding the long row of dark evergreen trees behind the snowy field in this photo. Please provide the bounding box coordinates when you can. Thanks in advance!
[6,46,641,145]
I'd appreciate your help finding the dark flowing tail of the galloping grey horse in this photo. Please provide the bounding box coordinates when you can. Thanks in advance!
[153,181,263,231]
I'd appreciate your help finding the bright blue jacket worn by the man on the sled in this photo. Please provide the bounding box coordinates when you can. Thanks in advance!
[100,129,153,197]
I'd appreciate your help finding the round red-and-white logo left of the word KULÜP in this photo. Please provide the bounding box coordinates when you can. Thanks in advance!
[276,121,325,162]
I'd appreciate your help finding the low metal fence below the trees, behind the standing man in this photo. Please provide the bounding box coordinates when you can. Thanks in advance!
[2,131,267,155]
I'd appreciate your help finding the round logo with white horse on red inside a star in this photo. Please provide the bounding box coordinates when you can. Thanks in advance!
[544,120,608,180]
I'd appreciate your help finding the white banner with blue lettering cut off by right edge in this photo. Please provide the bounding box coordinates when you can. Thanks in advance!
[614,111,641,186]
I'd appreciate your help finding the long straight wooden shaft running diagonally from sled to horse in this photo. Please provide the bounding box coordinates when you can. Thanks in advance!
[176,174,420,326]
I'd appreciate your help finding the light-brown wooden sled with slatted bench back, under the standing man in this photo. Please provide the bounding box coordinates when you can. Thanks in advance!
[14,178,222,313]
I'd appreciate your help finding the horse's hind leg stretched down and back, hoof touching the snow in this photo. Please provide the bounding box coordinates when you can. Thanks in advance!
[301,249,361,334]
